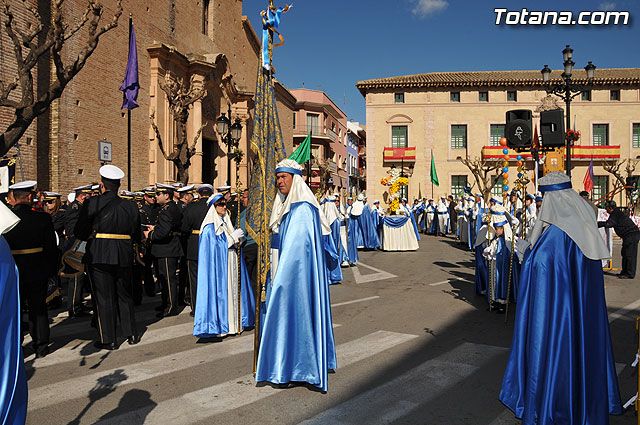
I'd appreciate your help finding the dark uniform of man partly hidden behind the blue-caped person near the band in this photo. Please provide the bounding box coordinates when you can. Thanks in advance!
[182,197,209,312]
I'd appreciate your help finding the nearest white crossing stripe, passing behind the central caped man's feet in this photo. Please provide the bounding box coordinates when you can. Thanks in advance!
[99,331,418,425]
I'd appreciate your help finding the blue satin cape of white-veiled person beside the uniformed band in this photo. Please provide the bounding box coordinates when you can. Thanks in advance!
[193,224,256,338]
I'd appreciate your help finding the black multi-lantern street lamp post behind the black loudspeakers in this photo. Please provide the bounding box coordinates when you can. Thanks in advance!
[540,44,596,177]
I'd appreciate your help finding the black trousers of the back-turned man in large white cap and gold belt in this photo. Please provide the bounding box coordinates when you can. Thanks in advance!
[89,264,138,344]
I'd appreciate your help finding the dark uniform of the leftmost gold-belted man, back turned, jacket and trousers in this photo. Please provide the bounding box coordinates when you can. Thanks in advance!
[4,204,58,356]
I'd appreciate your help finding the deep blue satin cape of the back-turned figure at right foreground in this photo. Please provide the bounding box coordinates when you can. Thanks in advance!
[500,225,622,425]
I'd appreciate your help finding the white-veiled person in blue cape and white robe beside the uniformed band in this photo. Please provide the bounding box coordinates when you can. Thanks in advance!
[193,193,255,338]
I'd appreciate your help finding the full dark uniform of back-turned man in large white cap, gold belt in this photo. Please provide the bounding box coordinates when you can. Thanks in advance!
[75,191,141,348]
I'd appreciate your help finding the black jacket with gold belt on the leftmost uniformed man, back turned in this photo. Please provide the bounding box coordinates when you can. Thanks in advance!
[4,204,59,282]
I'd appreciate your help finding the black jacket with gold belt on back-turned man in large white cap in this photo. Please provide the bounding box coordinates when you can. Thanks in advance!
[75,191,142,267]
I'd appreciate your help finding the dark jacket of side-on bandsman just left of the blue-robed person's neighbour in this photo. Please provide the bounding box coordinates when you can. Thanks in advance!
[148,201,183,258]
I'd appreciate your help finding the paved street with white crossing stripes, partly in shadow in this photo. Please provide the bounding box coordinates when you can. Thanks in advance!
[27,236,640,425]
